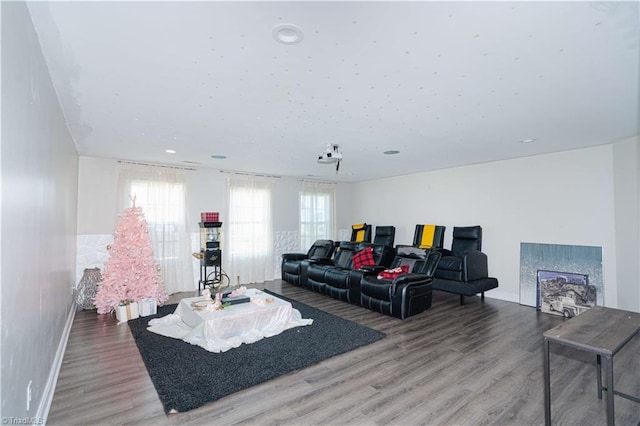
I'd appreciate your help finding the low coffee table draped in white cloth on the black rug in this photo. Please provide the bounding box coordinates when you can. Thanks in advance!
[148,289,313,352]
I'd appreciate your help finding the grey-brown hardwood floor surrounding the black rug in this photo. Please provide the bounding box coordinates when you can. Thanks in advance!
[47,280,640,426]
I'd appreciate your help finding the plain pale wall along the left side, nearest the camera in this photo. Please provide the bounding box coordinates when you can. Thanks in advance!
[0,2,78,420]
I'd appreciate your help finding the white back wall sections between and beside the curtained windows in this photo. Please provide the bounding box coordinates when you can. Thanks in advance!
[75,156,351,288]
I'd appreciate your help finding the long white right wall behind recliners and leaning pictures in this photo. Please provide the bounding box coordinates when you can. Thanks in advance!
[352,145,624,310]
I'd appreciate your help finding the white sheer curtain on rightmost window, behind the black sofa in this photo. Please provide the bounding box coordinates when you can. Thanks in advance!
[300,181,336,251]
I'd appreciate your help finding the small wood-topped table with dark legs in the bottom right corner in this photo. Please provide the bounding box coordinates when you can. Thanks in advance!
[543,306,640,425]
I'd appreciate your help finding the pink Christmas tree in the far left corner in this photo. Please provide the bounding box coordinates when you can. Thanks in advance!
[94,198,168,314]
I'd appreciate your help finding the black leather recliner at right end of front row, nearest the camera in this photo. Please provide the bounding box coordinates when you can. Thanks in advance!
[352,246,442,319]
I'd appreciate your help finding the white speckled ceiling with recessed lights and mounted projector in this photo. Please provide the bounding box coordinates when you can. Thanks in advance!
[29,1,640,182]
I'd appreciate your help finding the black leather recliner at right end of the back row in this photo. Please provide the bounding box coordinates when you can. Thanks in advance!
[433,226,498,305]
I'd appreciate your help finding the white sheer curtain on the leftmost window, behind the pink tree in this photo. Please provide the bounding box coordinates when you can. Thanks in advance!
[118,163,196,294]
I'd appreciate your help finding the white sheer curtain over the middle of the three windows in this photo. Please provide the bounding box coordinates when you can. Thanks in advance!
[222,175,274,284]
